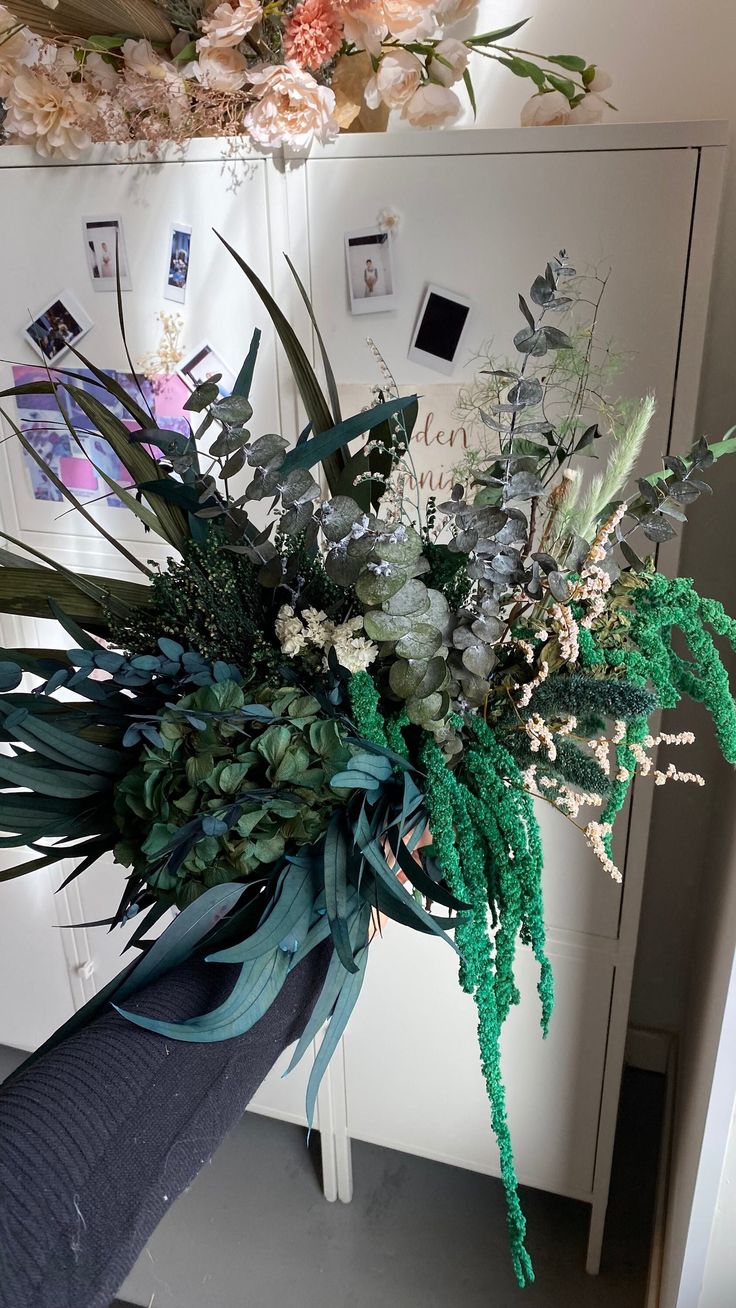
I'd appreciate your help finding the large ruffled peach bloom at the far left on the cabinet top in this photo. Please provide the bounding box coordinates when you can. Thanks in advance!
[5,68,90,160]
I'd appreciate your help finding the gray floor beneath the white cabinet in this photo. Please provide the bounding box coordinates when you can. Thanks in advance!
[109,1071,663,1308]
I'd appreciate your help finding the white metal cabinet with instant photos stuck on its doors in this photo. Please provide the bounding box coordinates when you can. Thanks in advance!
[0,124,724,1255]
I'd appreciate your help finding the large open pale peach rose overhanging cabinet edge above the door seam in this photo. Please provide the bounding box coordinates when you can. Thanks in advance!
[246,61,337,149]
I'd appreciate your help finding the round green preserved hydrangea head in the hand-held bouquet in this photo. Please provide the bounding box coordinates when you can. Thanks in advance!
[115,680,356,908]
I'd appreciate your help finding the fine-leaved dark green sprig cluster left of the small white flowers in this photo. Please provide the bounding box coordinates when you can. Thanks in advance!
[110,534,281,681]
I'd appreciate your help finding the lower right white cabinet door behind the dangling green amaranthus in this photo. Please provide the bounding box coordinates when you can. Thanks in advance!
[345,925,613,1198]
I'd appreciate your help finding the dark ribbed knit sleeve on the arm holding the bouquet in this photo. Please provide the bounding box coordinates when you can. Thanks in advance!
[0,946,329,1308]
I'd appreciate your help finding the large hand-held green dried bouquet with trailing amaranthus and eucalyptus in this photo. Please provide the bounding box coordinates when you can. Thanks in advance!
[0,240,736,1283]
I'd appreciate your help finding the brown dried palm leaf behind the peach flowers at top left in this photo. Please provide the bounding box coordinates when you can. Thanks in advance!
[12,0,174,41]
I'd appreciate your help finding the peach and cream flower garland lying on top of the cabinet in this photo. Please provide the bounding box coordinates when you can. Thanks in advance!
[0,0,611,158]
